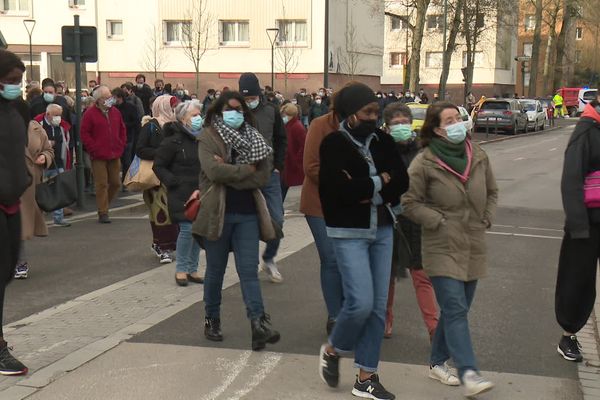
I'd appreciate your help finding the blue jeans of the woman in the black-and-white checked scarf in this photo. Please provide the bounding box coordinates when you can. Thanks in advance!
[204,214,264,319]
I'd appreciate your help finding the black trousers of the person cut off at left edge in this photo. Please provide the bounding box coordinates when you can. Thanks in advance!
[0,210,21,337]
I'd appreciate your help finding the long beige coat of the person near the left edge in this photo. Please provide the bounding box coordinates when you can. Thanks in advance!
[21,121,54,240]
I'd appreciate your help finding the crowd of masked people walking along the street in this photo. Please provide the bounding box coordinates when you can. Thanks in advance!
[0,50,600,400]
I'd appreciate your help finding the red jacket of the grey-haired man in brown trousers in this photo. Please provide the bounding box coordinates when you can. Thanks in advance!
[81,105,127,160]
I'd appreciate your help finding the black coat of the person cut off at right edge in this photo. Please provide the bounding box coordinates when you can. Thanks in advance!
[561,117,600,239]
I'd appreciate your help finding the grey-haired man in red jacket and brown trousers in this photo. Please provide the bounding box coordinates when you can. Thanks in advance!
[81,86,127,224]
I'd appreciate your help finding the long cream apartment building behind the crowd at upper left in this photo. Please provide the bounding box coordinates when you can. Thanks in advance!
[0,0,384,95]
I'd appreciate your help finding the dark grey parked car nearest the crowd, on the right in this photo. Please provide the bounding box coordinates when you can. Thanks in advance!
[475,99,528,135]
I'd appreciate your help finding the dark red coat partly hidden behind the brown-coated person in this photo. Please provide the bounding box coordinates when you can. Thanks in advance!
[283,117,306,187]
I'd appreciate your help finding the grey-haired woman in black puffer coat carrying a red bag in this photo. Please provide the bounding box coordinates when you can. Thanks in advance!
[152,100,204,286]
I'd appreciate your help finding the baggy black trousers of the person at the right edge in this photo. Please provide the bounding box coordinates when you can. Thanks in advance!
[554,225,600,333]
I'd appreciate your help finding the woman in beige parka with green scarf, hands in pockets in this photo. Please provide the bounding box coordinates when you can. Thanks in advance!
[402,102,498,397]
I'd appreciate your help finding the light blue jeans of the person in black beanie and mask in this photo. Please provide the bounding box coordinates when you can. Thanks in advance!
[329,225,393,372]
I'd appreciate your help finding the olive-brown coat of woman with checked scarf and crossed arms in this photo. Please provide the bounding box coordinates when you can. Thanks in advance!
[192,127,282,241]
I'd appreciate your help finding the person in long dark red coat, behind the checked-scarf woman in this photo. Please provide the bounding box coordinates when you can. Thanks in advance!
[281,103,306,201]
